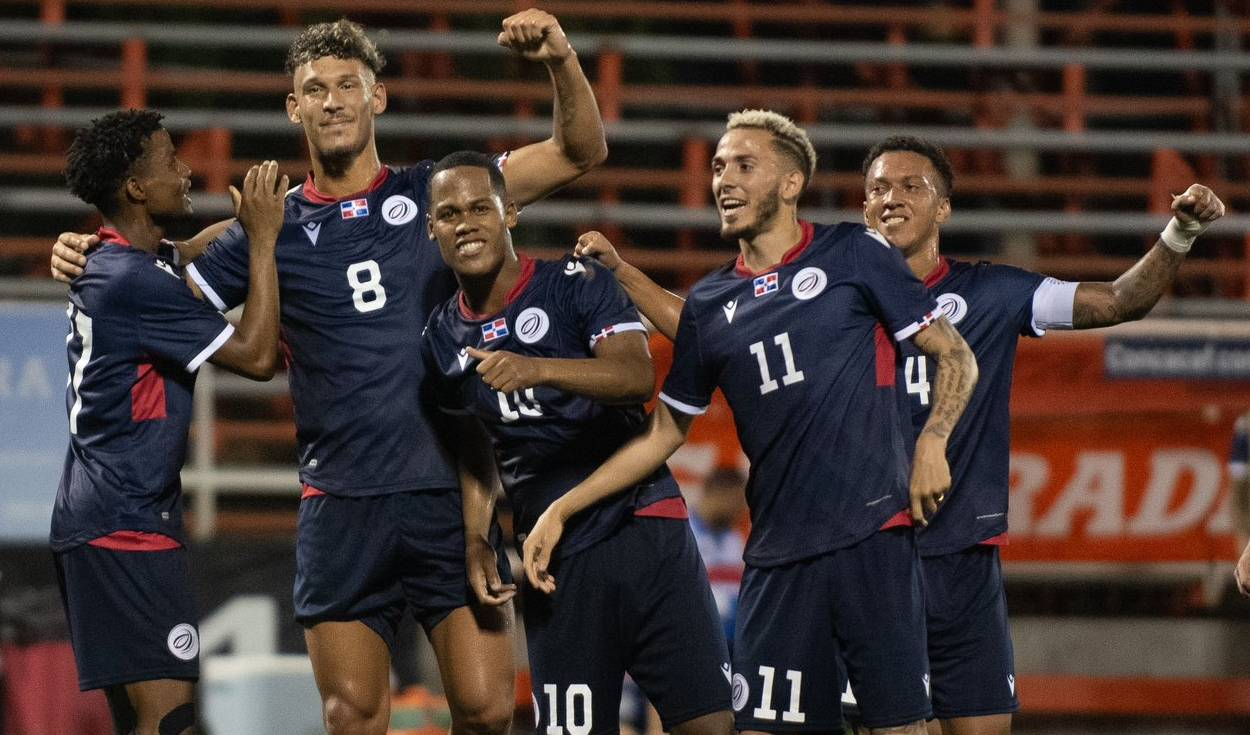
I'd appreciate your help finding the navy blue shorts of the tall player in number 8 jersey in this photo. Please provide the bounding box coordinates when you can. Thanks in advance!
[295,488,513,649]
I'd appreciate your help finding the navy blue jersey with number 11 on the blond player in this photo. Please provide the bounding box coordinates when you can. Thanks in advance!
[660,223,936,566]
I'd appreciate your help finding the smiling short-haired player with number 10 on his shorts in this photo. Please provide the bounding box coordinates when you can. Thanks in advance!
[424,151,734,735]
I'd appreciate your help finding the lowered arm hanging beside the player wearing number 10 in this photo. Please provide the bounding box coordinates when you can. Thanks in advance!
[454,416,516,605]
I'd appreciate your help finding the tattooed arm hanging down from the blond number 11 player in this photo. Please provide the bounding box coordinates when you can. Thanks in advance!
[911,316,976,525]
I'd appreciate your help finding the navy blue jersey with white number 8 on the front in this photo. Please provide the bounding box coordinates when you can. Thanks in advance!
[189,161,459,495]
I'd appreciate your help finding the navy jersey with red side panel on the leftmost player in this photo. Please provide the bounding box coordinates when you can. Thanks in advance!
[50,229,234,551]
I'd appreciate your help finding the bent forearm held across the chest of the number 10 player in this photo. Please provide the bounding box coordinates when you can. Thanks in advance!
[468,331,655,404]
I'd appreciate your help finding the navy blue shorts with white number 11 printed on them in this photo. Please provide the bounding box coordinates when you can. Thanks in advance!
[734,529,930,733]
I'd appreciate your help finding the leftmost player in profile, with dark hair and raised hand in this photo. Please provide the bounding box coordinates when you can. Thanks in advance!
[50,110,286,735]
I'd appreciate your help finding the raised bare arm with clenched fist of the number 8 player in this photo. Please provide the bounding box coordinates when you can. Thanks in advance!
[499,8,608,206]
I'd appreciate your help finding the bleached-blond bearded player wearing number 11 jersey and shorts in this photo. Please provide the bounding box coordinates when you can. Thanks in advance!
[524,110,976,733]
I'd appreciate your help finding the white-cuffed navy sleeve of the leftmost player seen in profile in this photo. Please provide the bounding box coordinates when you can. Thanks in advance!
[128,263,234,373]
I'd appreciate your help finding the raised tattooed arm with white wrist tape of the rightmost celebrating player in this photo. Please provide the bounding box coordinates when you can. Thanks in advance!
[1073,184,1224,329]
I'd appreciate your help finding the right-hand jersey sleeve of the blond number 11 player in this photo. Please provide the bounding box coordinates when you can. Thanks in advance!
[853,230,940,341]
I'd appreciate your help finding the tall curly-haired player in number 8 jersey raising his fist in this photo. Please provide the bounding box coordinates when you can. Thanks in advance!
[54,9,606,735]
